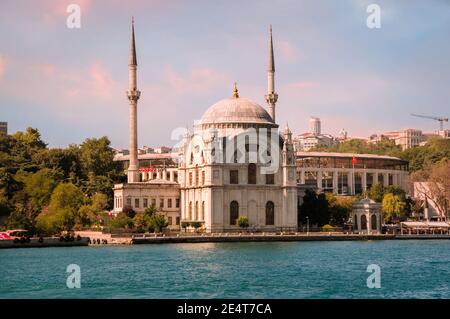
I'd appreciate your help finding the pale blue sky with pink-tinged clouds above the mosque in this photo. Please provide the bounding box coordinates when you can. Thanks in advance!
[0,0,450,148]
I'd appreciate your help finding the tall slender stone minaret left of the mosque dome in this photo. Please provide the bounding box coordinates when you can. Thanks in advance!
[127,18,141,183]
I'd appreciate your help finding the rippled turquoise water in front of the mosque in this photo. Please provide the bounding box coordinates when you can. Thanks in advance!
[0,240,450,299]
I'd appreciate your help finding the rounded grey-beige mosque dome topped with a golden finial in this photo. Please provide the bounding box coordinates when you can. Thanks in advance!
[201,87,276,126]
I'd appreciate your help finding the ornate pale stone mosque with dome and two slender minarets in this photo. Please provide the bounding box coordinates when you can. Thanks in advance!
[114,21,299,232]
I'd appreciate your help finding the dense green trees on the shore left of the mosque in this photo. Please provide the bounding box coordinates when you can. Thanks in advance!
[0,128,126,234]
